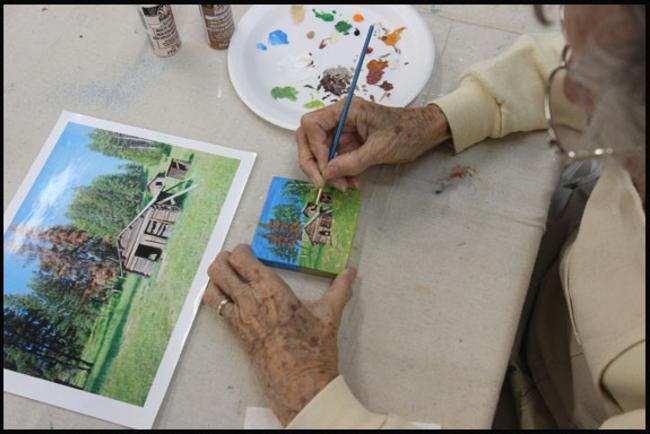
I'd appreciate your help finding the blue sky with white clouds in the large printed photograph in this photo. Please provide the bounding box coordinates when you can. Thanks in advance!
[3,123,134,294]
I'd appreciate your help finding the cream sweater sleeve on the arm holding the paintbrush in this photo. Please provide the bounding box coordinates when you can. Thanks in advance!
[431,33,585,152]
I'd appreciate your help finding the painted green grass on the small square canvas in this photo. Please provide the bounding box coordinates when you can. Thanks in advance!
[298,188,361,274]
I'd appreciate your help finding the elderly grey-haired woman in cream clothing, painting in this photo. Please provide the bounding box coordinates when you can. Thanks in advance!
[204,5,645,428]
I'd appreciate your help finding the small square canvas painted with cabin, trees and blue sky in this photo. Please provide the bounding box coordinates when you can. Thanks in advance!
[252,176,361,276]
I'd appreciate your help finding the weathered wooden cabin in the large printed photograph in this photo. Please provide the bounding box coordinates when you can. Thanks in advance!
[117,180,198,277]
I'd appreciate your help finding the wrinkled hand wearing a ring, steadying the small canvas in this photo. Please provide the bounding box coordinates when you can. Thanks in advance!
[203,244,356,426]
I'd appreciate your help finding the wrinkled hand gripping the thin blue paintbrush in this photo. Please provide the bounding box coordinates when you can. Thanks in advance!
[296,97,451,191]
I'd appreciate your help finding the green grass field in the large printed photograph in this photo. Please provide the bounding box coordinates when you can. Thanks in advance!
[78,148,239,406]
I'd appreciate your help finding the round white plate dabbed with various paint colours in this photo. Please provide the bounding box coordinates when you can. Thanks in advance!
[228,5,435,130]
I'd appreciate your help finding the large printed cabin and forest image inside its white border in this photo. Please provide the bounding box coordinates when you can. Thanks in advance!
[3,122,240,406]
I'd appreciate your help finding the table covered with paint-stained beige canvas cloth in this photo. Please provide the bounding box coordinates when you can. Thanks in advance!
[3,5,560,428]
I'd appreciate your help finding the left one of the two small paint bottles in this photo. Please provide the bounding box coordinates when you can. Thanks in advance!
[138,5,181,57]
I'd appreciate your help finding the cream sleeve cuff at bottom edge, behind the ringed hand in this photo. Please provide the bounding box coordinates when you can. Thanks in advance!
[287,375,417,429]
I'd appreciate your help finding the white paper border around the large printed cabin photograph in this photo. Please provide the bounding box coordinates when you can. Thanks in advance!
[3,111,257,429]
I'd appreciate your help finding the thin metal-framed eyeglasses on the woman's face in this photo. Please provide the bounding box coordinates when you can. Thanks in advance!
[544,6,638,161]
